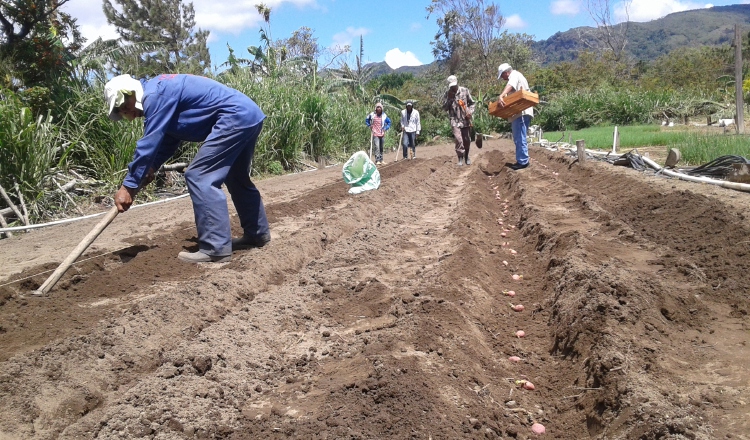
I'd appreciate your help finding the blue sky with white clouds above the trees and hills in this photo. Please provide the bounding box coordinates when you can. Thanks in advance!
[63,0,750,68]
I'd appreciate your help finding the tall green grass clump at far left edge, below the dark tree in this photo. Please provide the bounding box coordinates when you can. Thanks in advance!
[0,91,63,216]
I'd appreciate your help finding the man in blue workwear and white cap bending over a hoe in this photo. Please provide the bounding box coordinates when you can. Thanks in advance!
[104,74,271,263]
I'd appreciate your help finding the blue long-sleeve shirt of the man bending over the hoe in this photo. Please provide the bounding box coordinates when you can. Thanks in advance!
[123,75,266,188]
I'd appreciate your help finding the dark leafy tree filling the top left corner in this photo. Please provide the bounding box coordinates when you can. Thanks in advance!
[0,0,85,87]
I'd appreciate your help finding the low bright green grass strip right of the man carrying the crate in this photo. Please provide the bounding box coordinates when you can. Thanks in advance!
[544,125,689,150]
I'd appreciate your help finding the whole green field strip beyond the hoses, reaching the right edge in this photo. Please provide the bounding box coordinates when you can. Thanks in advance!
[544,125,750,165]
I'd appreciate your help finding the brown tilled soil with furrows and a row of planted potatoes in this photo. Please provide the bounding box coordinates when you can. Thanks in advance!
[0,140,750,440]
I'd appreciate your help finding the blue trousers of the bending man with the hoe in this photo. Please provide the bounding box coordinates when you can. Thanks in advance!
[185,118,269,256]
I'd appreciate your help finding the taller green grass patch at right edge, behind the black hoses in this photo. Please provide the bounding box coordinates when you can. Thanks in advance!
[668,133,750,165]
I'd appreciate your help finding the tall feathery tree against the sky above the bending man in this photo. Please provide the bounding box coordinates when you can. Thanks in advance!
[103,0,211,76]
